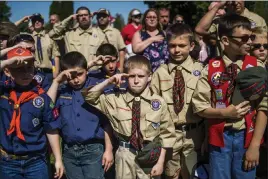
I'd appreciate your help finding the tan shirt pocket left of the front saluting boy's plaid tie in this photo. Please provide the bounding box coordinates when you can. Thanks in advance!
[111,111,132,136]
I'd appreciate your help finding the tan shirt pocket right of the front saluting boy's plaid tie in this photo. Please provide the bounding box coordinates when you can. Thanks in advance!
[145,112,161,138]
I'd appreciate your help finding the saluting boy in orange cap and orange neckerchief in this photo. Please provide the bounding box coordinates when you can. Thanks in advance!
[0,48,63,179]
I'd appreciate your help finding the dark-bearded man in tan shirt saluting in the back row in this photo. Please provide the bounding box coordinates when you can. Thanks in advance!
[49,6,105,67]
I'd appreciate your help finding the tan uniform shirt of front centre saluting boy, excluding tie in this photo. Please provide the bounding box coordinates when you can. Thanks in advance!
[83,87,176,148]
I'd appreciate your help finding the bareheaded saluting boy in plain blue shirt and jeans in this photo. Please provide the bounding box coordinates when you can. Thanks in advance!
[48,52,113,179]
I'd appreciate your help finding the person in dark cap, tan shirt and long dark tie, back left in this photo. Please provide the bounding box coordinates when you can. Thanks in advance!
[31,13,60,81]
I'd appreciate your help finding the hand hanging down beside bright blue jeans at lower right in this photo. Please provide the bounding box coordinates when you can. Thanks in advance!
[244,146,260,171]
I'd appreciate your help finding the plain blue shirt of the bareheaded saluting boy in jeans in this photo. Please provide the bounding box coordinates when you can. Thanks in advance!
[56,75,108,144]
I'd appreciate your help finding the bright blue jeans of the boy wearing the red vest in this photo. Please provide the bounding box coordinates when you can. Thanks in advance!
[209,130,256,179]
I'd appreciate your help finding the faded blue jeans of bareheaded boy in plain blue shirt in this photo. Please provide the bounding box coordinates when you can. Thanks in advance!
[63,143,104,179]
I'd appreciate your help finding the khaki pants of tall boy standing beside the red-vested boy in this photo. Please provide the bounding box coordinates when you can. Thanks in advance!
[165,125,205,177]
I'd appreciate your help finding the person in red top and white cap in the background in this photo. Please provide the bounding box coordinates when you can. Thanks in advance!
[121,9,142,56]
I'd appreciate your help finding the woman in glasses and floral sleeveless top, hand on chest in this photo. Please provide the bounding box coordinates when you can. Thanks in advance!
[132,9,169,72]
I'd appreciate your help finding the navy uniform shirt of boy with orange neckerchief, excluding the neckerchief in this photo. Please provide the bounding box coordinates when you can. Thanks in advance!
[0,76,58,156]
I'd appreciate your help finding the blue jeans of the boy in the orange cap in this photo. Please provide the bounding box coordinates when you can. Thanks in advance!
[0,156,49,179]
